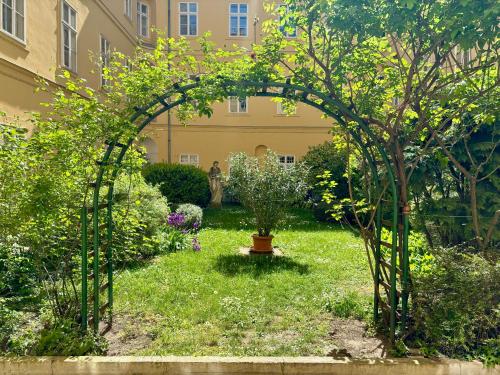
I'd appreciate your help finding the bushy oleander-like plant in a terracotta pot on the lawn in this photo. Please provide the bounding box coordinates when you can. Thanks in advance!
[228,151,307,253]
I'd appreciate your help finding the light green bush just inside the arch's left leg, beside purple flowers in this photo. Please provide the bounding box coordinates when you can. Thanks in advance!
[113,174,169,265]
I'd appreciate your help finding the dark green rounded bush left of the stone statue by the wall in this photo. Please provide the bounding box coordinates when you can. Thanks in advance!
[143,163,210,207]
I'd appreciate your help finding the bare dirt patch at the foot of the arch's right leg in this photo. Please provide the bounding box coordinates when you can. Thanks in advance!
[328,319,387,358]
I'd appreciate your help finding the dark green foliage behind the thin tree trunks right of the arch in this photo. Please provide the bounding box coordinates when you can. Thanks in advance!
[410,123,500,247]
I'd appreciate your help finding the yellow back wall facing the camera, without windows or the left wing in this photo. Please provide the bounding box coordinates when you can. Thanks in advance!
[147,0,331,171]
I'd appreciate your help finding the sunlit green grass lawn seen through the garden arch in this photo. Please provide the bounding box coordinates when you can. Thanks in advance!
[115,206,372,356]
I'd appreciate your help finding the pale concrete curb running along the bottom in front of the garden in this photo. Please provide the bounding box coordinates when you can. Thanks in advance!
[0,356,500,375]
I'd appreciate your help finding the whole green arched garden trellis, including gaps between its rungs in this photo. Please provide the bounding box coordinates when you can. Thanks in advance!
[81,77,409,339]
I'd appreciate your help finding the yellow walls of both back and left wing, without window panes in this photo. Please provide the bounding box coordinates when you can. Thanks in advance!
[0,0,331,169]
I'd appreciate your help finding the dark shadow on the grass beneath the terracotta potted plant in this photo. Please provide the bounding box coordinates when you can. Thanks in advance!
[214,254,309,277]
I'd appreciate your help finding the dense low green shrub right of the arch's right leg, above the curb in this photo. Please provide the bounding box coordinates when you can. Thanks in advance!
[413,248,500,363]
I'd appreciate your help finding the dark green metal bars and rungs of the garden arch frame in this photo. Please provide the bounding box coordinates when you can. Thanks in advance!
[81,77,409,340]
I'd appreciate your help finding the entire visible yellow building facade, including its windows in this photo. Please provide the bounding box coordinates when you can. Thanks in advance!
[0,0,331,170]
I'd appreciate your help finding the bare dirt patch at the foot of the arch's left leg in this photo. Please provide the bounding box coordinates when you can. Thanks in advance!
[104,315,155,356]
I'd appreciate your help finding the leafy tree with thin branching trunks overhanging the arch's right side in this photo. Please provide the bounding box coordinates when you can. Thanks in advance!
[248,0,500,248]
